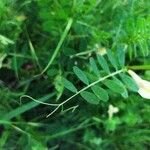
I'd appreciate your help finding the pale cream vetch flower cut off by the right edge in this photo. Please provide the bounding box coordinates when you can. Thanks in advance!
[128,70,150,99]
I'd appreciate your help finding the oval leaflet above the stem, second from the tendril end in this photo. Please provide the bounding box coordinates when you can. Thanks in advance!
[73,66,89,85]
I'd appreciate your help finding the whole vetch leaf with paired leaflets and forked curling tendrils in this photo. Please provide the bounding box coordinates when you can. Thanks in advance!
[22,46,142,117]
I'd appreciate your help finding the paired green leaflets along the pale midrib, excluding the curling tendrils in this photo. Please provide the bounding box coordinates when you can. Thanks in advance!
[65,48,138,104]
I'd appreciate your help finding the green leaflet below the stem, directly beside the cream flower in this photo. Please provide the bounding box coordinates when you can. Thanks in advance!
[120,74,139,92]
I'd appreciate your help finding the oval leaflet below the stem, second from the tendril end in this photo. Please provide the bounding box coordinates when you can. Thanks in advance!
[91,85,109,102]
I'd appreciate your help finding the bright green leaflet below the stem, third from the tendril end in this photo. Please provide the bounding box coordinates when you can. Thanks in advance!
[104,79,124,94]
